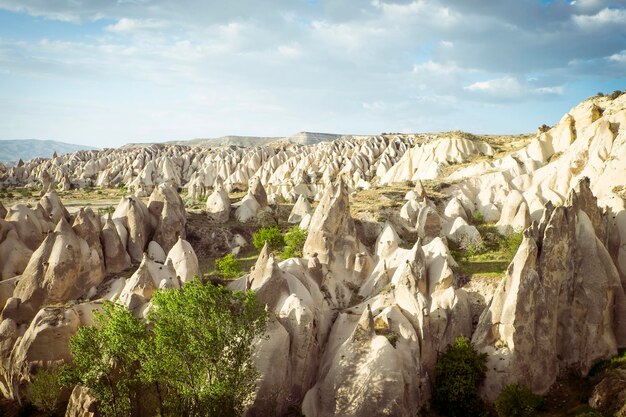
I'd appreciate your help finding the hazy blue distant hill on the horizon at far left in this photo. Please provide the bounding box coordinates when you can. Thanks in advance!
[0,139,96,164]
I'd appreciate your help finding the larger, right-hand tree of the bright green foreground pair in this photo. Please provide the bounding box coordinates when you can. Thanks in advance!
[143,280,267,417]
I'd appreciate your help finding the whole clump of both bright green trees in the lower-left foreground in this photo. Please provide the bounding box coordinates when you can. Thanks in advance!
[68,279,267,417]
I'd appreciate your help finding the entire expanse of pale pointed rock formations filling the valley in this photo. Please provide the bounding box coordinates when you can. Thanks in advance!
[0,95,626,417]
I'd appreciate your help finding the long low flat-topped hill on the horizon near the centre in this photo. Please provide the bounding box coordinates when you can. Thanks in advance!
[118,132,344,147]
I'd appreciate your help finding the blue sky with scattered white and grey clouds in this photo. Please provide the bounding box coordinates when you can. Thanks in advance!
[0,0,626,147]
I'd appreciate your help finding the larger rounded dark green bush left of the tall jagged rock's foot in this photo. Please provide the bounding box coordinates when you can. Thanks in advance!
[433,337,487,417]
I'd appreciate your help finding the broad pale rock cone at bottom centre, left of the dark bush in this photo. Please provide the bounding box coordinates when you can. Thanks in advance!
[302,307,420,417]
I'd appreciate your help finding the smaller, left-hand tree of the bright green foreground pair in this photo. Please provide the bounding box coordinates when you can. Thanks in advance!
[70,302,148,417]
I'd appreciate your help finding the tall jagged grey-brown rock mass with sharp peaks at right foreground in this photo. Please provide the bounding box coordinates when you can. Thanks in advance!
[472,181,626,399]
